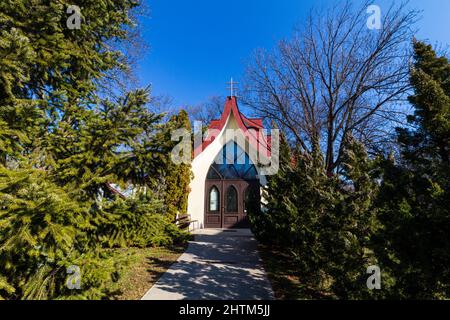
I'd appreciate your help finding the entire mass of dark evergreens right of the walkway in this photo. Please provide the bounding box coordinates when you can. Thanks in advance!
[251,41,450,299]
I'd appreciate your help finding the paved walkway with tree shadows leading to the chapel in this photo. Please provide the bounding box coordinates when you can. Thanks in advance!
[142,229,273,300]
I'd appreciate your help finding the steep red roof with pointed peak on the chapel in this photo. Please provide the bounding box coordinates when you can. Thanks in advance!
[194,97,271,157]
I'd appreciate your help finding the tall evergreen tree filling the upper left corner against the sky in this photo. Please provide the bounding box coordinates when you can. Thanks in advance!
[0,0,138,164]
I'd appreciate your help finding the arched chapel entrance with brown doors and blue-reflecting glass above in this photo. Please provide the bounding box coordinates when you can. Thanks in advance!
[205,143,260,228]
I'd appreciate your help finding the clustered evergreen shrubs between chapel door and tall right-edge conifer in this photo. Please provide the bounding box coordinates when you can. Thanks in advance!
[251,134,376,298]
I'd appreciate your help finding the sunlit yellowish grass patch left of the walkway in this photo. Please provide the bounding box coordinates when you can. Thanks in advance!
[110,244,187,300]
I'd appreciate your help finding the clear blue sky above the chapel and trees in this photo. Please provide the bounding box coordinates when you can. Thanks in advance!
[137,0,450,106]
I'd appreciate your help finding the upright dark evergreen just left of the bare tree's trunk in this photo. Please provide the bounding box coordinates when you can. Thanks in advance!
[286,148,336,292]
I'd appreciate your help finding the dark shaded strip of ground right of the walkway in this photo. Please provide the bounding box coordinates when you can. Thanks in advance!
[258,244,331,300]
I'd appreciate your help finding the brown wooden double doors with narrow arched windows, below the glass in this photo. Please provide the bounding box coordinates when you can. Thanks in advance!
[205,180,260,228]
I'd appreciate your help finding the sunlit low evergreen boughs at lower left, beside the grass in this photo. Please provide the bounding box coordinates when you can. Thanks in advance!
[0,168,186,299]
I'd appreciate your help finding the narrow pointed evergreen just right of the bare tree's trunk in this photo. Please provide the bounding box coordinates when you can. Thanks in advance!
[327,135,378,299]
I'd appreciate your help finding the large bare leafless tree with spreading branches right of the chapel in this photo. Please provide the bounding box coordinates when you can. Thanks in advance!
[245,2,418,174]
